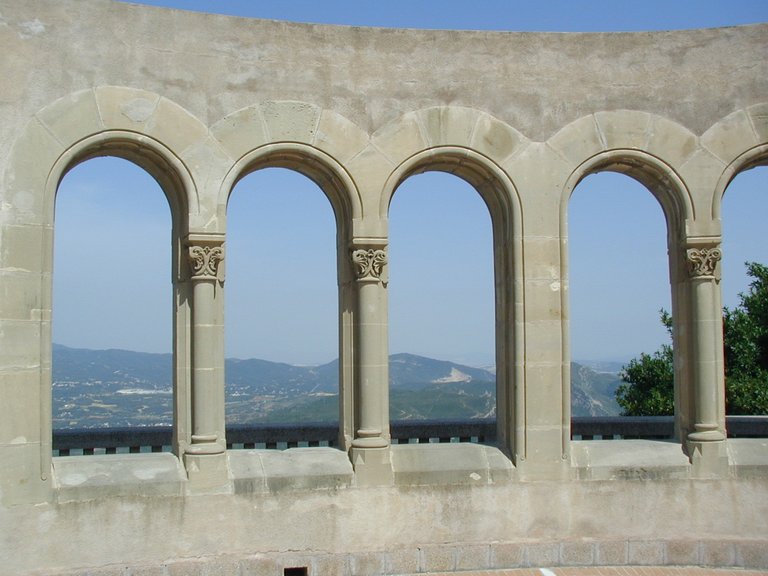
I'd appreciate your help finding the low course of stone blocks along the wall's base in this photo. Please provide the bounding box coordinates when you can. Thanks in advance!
[19,539,768,576]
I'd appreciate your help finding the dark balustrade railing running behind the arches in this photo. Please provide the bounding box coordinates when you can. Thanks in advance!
[53,416,768,456]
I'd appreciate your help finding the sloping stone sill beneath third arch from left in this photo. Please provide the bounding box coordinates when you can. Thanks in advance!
[392,444,514,486]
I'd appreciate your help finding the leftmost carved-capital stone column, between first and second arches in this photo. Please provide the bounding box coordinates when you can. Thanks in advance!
[184,236,227,490]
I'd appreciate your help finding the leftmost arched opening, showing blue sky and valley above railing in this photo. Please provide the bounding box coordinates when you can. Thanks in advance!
[52,157,173,430]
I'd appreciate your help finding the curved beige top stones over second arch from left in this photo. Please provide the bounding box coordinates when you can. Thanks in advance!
[211,100,368,164]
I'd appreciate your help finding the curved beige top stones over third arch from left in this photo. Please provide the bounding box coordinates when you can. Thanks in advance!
[371,106,528,166]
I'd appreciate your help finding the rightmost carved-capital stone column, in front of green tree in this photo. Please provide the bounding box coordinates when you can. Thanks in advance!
[685,244,727,476]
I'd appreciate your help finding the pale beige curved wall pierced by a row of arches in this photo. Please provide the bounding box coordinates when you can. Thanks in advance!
[0,0,768,568]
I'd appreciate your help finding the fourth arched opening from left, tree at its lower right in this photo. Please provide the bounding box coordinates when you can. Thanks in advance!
[568,172,674,424]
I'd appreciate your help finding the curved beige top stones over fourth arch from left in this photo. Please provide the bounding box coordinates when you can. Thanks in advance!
[547,110,698,167]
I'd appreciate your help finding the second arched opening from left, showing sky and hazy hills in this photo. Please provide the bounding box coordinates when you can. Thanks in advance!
[225,168,339,432]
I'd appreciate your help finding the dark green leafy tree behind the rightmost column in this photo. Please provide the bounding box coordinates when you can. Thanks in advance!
[616,262,768,416]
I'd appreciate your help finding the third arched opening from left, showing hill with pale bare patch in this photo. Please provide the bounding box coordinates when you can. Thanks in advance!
[388,172,496,420]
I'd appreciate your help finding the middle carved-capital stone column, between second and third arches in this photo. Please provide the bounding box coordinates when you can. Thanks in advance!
[350,243,392,484]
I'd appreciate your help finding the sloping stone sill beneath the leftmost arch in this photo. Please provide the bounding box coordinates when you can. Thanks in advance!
[53,453,187,502]
